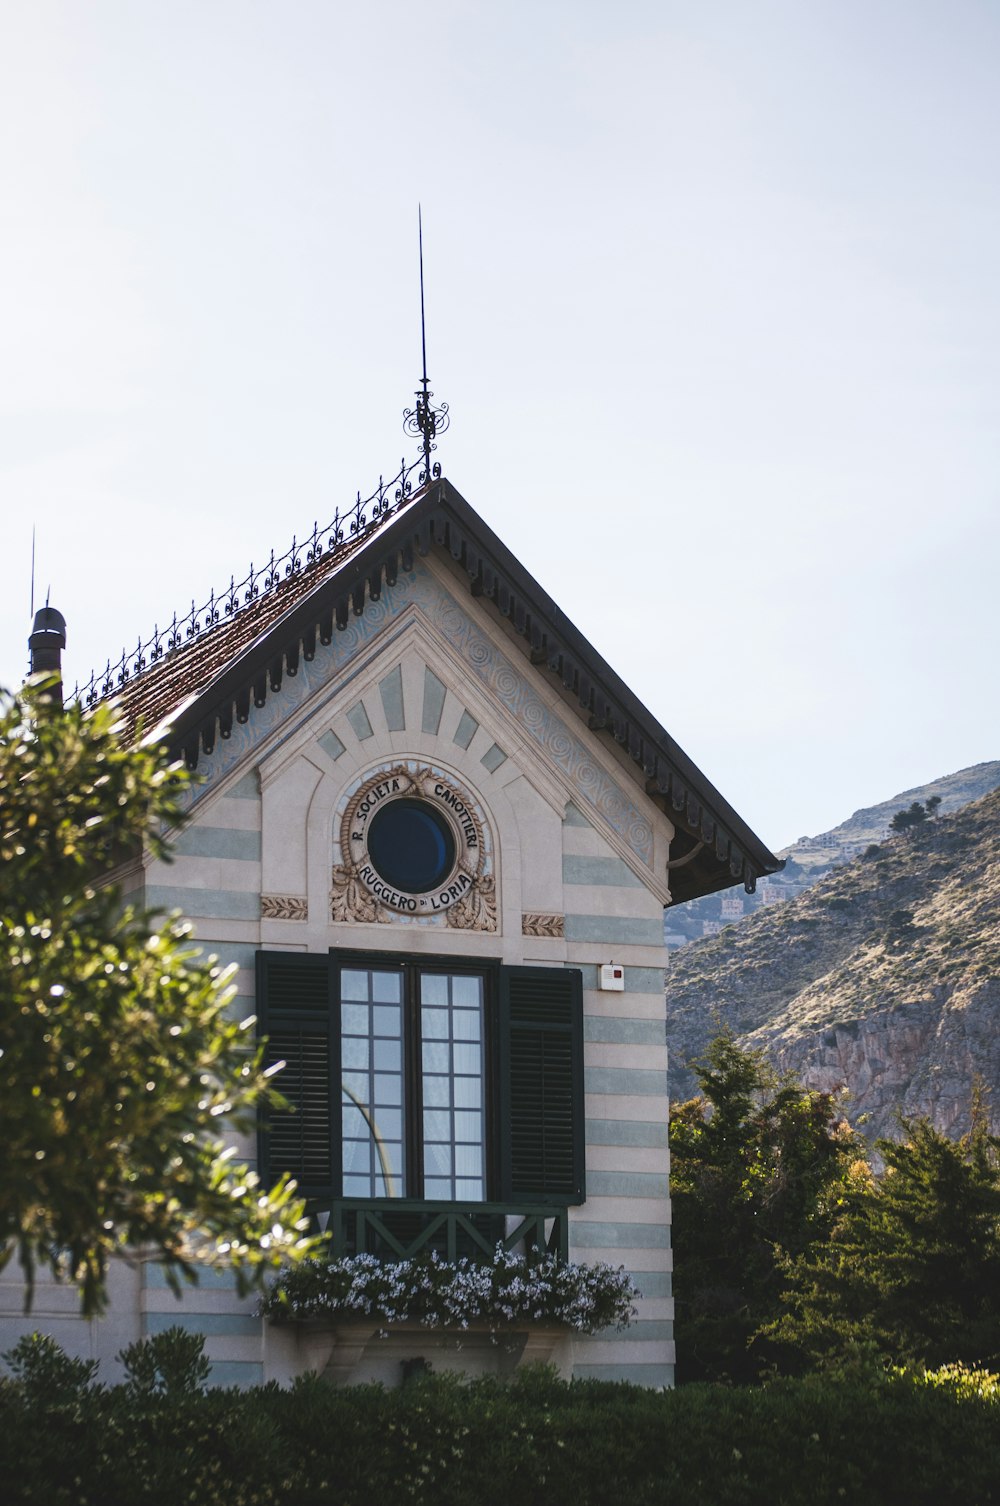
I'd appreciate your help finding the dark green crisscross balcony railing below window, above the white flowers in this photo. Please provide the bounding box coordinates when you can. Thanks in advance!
[327,1197,569,1264]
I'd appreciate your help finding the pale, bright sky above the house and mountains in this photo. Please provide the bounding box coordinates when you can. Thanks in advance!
[0,0,1000,848]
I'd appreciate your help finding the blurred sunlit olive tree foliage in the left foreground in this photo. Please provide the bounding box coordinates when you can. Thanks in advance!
[0,684,315,1315]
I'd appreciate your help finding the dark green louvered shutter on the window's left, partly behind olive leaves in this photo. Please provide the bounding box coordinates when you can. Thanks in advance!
[258,952,340,1197]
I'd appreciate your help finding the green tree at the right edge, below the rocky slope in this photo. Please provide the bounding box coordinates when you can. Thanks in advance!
[765,1111,1000,1369]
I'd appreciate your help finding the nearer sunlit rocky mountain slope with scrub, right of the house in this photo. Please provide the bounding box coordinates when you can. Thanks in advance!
[667,786,1000,1136]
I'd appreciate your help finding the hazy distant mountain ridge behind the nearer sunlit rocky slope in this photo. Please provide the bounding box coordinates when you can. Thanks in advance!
[664,761,1000,949]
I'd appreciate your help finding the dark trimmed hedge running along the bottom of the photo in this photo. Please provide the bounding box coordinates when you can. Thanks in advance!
[0,1369,1000,1506]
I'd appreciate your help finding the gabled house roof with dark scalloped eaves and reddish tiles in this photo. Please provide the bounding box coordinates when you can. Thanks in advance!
[101,480,780,899]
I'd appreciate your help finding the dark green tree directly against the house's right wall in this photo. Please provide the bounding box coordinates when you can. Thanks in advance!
[670,1033,861,1381]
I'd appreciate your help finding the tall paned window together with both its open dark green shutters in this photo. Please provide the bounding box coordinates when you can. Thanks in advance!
[258,952,584,1203]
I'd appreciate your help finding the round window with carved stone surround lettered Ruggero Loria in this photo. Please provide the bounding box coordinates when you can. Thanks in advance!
[330,764,497,931]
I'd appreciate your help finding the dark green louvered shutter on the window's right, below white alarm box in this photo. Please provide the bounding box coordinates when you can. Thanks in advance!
[498,967,586,1203]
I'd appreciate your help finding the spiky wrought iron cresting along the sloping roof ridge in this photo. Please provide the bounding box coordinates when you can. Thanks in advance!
[69,455,430,706]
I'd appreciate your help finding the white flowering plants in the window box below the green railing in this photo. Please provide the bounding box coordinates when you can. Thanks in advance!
[261,1244,639,1333]
